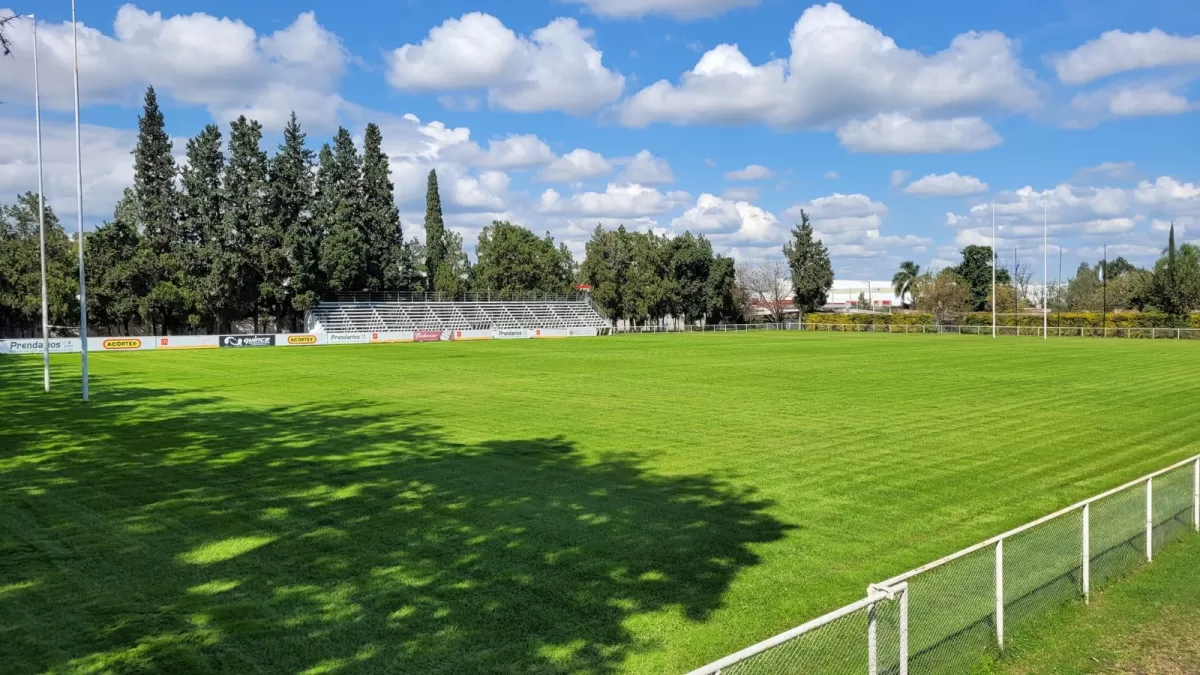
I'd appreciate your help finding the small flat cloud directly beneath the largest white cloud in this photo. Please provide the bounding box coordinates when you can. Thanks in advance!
[838,113,1003,153]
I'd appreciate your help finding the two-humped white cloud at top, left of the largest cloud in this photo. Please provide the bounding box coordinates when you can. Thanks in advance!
[388,12,625,114]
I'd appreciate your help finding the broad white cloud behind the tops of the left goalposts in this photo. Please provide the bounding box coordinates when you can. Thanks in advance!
[0,5,347,129]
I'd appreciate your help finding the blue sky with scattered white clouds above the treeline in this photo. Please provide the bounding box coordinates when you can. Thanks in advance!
[0,0,1200,277]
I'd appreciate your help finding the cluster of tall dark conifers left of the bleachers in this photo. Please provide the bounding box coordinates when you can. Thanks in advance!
[77,88,421,333]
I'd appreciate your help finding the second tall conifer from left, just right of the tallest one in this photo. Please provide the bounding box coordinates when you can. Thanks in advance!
[178,125,224,329]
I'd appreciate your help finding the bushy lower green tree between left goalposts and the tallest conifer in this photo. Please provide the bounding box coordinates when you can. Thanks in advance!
[84,189,146,335]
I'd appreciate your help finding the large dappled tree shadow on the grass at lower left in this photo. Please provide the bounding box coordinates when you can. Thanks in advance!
[0,359,786,673]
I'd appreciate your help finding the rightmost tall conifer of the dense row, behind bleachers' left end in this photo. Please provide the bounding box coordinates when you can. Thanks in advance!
[362,123,404,291]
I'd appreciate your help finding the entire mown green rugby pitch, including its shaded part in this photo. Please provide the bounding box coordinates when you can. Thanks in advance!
[0,333,1200,674]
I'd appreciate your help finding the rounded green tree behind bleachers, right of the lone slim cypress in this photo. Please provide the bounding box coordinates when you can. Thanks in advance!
[474,221,575,298]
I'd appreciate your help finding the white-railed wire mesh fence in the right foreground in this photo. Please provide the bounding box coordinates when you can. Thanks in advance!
[689,456,1200,675]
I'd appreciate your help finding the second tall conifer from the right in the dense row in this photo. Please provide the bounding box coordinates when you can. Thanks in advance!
[320,127,367,291]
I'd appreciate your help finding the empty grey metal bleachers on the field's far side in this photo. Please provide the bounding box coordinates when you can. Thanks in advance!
[305,298,611,333]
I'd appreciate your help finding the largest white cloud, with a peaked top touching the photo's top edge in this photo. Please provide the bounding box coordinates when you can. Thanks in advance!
[619,2,1037,126]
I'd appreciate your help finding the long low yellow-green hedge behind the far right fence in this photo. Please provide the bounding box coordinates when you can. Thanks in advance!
[804,312,1200,328]
